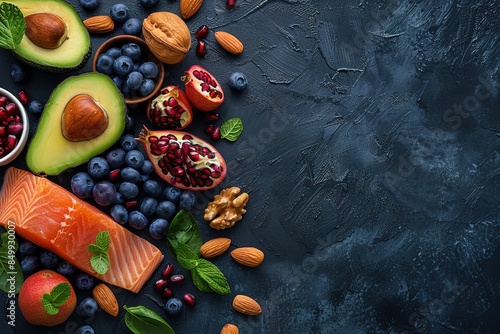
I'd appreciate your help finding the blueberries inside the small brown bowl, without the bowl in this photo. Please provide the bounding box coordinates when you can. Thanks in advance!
[96,42,160,98]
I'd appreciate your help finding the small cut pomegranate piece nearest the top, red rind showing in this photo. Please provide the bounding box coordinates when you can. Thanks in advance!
[181,65,224,111]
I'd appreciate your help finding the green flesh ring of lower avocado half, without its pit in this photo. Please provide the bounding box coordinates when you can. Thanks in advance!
[26,72,126,175]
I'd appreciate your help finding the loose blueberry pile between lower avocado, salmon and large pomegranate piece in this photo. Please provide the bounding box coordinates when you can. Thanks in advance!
[71,133,196,240]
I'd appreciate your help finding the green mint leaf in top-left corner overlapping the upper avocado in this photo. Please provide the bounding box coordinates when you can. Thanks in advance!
[0,2,26,50]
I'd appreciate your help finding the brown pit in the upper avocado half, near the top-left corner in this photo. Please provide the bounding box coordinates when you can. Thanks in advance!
[24,13,68,49]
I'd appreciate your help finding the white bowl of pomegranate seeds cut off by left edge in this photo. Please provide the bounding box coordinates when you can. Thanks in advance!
[0,88,29,166]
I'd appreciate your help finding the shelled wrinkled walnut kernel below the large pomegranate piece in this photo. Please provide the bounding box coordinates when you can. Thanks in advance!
[203,187,248,230]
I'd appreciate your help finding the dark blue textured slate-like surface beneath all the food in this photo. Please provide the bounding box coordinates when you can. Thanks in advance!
[0,0,500,334]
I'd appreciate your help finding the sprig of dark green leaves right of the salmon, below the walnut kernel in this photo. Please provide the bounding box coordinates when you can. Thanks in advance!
[167,210,231,295]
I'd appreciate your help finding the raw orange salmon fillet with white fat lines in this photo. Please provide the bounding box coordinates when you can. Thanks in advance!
[0,167,163,293]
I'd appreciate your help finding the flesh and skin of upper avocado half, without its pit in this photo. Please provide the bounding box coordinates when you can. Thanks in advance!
[6,0,92,73]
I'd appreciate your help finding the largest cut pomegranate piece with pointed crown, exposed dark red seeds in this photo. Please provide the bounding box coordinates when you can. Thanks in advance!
[136,127,226,191]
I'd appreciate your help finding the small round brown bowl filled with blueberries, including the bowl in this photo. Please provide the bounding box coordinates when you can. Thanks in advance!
[92,35,165,104]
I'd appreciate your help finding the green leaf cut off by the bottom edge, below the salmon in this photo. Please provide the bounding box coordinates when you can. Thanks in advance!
[123,305,175,334]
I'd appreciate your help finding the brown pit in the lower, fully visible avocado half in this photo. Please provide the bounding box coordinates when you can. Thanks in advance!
[61,94,108,141]
